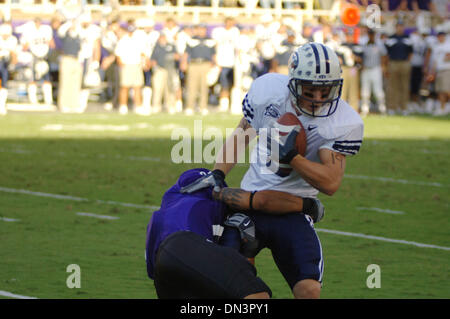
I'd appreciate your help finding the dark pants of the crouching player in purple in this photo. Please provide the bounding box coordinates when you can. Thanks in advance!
[154,231,272,299]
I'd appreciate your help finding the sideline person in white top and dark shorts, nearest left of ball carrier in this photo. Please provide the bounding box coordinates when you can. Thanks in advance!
[212,17,240,112]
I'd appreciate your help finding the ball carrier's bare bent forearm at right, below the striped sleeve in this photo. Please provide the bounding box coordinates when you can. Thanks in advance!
[290,154,343,196]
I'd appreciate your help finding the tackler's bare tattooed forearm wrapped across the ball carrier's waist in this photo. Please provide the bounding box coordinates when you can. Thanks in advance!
[213,187,303,214]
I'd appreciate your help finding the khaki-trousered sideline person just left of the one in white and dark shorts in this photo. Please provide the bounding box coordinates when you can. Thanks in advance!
[184,25,215,115]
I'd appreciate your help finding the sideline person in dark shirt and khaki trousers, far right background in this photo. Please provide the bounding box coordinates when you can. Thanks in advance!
[385,21,412,115]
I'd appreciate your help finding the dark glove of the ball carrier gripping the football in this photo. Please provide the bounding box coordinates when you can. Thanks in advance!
[267,125,300,164]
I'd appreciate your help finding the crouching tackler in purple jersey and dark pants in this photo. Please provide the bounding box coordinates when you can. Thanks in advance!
[146,169,271,299]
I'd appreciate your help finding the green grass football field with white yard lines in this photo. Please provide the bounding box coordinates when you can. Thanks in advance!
[0,113,450,298]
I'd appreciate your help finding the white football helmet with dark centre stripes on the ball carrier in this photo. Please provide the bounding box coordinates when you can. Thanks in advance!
[288,42,343,117]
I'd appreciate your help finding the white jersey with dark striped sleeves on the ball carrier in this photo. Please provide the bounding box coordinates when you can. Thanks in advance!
[241,73,364,197]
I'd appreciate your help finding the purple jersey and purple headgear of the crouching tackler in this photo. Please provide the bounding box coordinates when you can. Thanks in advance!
[146,168,226,279]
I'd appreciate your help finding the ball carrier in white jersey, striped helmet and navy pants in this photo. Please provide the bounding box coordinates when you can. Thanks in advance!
[181,42,364,298]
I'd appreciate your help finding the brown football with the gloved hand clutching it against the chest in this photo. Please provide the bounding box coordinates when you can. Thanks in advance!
[267,112,306,177]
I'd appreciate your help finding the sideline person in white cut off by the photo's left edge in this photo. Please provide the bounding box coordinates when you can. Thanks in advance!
[0,23,18,115]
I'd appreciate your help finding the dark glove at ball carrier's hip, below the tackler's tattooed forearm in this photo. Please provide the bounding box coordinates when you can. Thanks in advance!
[224,213,259,258]
